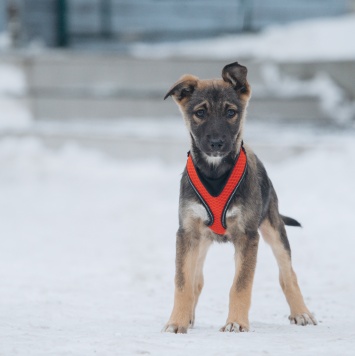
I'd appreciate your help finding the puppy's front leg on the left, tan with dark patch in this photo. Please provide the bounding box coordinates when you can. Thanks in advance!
[163,230,199,333]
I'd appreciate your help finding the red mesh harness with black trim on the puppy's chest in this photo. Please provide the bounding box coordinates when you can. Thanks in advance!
[186,147,247,235]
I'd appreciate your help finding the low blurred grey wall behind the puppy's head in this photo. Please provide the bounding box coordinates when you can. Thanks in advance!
[0,52,355,123]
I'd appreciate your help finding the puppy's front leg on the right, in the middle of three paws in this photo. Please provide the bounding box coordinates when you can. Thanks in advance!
[220,232,259,332]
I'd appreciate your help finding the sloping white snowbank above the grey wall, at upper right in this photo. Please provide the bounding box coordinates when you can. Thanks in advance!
[131,14,355,62]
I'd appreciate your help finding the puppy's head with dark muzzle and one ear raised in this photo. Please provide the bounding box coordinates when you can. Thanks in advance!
[164,62,251,161]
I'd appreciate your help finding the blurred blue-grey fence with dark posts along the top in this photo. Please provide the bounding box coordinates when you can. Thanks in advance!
[0,0,352,48]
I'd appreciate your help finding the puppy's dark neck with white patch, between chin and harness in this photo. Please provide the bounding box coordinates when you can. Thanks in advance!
[190,140,241,179]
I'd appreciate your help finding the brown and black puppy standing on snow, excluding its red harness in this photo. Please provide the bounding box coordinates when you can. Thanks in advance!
[164,63,317,333]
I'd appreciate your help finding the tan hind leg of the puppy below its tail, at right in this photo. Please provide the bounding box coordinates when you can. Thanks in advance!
[260,214,317,325]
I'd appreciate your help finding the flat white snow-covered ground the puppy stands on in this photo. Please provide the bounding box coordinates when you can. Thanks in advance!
[0,121,355,356]
